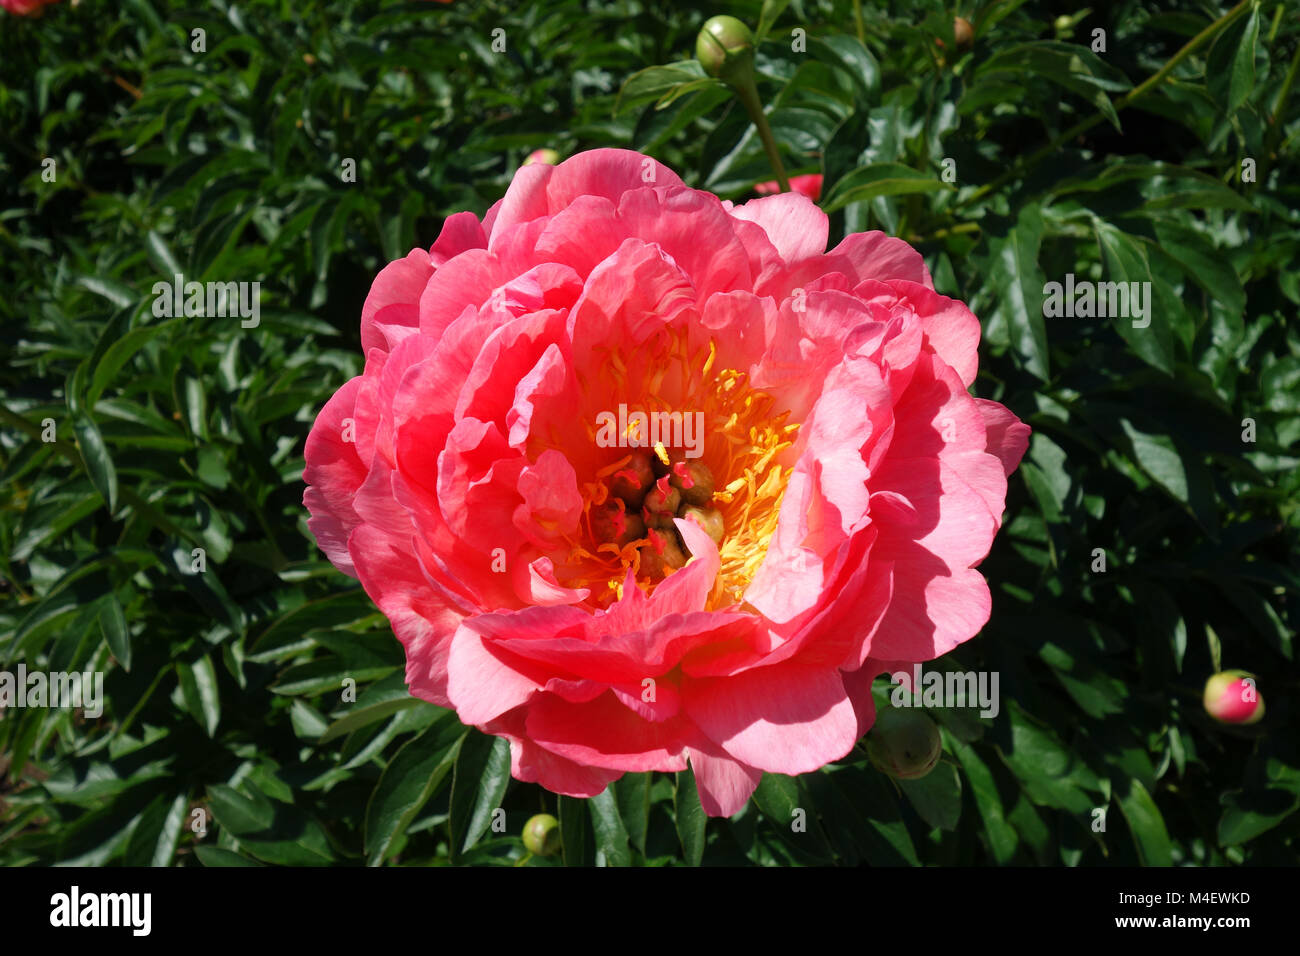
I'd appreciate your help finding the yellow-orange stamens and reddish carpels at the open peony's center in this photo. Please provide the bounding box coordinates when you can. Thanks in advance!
[556,329,798,609]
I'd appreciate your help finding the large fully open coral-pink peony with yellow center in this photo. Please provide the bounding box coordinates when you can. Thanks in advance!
[304,150,1030,816]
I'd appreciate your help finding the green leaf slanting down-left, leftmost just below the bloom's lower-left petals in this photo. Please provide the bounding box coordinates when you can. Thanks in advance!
[365,713,467,866]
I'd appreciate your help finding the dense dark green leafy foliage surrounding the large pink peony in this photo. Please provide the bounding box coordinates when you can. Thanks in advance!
[0,0,1300,866]
